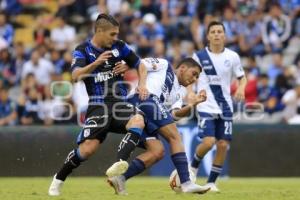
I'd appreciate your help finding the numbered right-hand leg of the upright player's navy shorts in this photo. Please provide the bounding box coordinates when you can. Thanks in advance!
[216,117,232,141]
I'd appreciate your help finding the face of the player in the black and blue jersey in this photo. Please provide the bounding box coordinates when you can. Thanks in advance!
[98,27,119,48]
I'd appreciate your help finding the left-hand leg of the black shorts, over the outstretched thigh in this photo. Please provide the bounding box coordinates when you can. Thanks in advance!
[77,105,112,144]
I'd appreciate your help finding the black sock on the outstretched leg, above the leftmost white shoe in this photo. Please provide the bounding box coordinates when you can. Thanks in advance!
[56,148,86,181]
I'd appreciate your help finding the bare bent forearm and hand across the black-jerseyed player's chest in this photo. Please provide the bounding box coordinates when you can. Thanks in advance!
[72,51,111,81]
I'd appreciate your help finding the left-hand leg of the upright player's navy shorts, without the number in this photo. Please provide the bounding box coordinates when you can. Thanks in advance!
[197,112,216,138]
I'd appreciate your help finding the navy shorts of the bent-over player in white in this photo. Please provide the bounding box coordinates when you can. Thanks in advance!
[128,94,174,134]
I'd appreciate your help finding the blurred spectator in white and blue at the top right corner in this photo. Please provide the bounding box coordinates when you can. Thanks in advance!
[262,3,292,53]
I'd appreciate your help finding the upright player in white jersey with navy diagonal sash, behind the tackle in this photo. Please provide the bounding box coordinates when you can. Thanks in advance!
[191,21,247,192]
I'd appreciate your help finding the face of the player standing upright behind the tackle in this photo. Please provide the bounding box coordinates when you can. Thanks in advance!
[207,25,225,45]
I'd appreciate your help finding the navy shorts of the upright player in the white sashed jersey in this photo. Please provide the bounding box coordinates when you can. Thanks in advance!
[198,112,232,141]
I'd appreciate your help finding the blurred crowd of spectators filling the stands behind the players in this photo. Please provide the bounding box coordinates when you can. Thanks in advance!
[0,0,300,126]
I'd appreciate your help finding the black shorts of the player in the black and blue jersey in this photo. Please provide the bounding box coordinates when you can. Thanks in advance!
[77,102,139,144]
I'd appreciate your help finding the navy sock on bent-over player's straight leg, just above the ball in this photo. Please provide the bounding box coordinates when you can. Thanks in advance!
[171,152,190,184]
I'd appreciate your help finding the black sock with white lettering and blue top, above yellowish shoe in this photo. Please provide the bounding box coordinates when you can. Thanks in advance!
[117,128,143,161]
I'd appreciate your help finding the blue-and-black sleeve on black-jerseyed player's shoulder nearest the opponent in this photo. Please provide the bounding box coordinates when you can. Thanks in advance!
[118,41,141,68]
